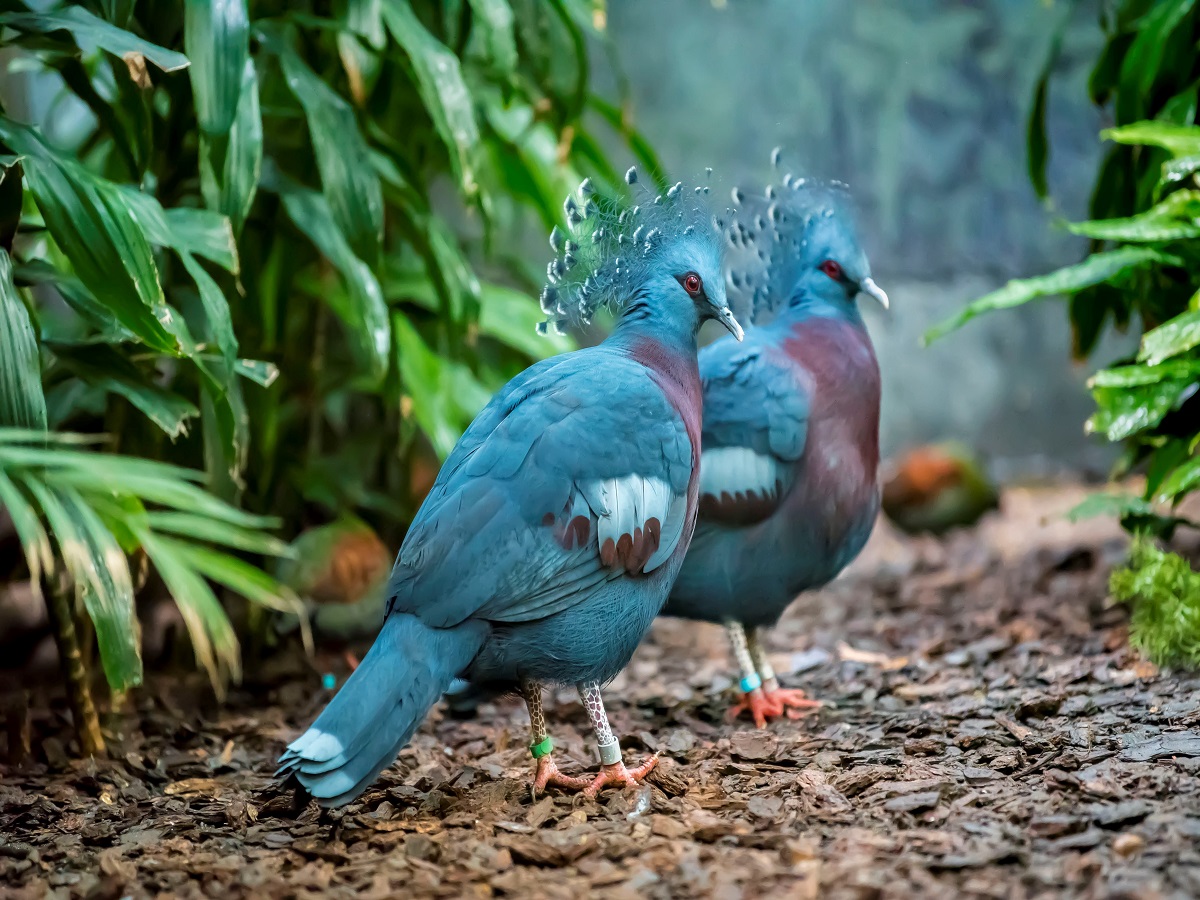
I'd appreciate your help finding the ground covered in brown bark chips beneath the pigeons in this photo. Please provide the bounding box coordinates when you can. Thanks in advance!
[0,488,1200,900]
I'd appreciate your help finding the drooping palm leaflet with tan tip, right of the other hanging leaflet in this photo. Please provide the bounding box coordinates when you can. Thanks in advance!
[138,529,241,698]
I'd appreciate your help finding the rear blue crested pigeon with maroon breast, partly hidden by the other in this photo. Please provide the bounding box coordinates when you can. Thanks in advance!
[664,165,888,727]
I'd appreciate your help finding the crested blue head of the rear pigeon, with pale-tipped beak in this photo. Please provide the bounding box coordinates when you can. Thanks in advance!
[730,160,888,318]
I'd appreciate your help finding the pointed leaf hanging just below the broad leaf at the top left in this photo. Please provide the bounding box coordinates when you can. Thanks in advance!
[200,59,263,234]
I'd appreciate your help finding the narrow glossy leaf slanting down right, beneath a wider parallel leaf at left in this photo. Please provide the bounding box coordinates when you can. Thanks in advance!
[274,186,391,378]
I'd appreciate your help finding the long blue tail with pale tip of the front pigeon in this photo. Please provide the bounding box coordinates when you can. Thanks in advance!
[278,614,488,806]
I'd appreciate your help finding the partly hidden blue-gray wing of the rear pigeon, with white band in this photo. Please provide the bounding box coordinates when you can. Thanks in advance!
[700,332,809,524]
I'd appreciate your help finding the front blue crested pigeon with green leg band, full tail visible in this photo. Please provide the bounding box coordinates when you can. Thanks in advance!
[280,169,742,806]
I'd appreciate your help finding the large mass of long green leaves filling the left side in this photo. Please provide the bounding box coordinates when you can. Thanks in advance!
[0,0,658,688]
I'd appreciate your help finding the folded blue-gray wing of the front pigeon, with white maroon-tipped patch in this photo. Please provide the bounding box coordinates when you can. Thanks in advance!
[389,347,692,626]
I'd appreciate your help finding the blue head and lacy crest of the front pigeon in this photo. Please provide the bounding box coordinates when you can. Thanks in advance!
[539,168,742,341]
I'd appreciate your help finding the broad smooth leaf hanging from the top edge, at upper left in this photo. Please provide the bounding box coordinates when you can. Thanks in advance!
[184,0,250,137]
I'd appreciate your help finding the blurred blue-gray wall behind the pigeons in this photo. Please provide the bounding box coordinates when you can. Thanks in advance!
[608,0,1118,475]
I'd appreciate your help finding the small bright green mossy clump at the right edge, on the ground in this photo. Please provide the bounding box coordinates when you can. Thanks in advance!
[1109,535,1200,668]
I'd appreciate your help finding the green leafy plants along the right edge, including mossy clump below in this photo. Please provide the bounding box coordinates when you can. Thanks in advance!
[929,0,1200,665]
